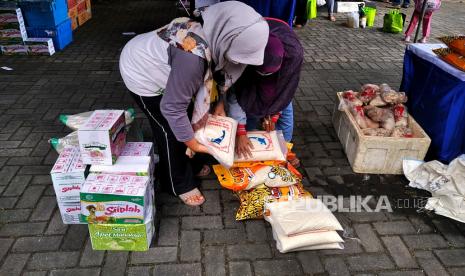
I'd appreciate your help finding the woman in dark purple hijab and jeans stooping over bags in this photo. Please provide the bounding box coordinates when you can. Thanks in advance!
[228,18,303,166]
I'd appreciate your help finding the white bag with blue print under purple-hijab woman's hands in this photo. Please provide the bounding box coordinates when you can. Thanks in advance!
[234,131,286,162]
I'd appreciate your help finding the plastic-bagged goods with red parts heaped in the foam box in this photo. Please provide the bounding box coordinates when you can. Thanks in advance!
[339,84,413,138]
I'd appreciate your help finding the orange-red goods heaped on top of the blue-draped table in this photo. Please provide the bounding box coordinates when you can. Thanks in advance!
[433,36,465,71]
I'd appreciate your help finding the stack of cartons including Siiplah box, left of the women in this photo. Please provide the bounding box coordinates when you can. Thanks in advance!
[50,110,156,251]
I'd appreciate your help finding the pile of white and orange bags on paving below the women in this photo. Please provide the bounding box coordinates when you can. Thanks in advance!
[203,125,344,253]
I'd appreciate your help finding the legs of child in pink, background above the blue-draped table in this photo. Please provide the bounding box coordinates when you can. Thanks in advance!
[404,0,441,43]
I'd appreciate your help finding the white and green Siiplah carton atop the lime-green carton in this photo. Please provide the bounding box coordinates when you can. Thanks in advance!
[81,173,153,224]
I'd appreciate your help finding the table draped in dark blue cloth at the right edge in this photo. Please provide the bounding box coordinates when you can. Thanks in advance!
[400,44,465,163]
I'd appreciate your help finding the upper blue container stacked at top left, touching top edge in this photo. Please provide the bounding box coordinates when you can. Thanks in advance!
[19,0,68,27]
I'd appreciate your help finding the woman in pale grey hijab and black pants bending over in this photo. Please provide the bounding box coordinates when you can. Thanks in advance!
[119,1,269,206]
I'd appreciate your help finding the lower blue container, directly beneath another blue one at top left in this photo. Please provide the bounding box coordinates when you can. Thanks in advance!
[27,19,73,51]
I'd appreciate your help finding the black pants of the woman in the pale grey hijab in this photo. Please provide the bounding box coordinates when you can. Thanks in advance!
[131,93,204,196]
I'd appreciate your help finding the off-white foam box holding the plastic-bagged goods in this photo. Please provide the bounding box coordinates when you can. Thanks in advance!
[332,92,431,174]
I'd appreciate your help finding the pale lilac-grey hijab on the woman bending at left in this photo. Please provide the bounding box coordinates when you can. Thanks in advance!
[201,1,269,86]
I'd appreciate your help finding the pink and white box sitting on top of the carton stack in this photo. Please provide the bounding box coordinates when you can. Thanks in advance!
[78,110,127,165]
